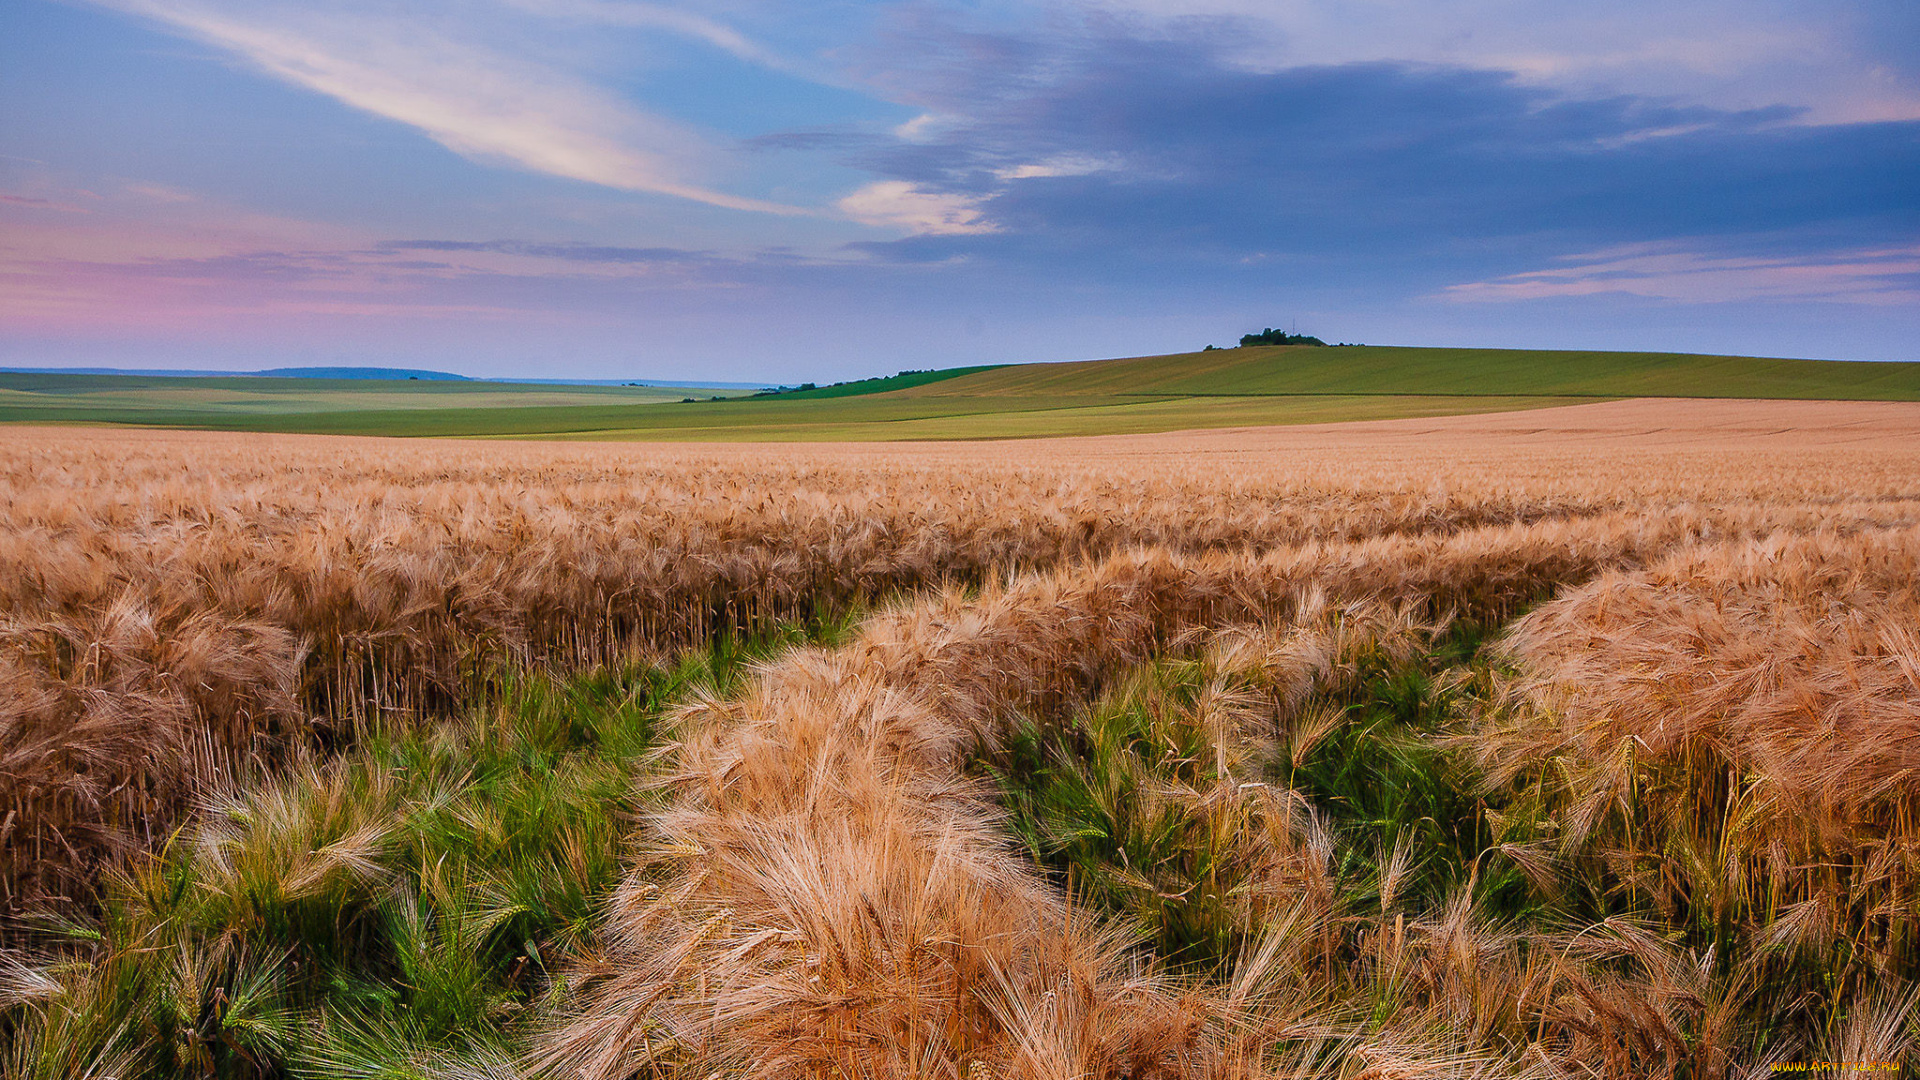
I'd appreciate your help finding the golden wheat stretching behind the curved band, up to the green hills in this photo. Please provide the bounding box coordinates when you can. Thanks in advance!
[0,404,1920,980]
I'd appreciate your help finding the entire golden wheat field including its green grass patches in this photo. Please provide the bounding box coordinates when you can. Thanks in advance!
[0,400,1920,1080]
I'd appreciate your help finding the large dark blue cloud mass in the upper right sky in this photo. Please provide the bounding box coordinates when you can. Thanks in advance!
[851,17,1920,274]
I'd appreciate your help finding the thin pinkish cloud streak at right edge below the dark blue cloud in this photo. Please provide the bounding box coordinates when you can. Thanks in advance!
[1442,244,1920,306]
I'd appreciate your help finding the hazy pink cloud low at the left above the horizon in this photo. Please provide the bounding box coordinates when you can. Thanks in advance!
[0,184,748,336]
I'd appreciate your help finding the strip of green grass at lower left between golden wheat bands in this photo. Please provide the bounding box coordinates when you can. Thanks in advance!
[0,618,825,1080]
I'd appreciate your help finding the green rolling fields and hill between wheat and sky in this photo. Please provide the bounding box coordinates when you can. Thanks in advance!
[0,346,1920,442]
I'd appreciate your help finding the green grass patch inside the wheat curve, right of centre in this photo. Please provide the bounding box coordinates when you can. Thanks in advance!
[977,623,1542,972]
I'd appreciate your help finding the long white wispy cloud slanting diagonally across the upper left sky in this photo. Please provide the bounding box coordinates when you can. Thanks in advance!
[98,0,804,213]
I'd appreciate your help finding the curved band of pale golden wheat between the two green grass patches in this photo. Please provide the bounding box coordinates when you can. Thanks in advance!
[538,527,1728,1078]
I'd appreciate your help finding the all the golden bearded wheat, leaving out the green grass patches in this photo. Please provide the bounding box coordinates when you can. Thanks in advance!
[0,404,1920,1078]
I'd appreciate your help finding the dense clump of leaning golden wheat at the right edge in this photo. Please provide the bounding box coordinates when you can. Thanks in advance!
[1467,530,1920,1053]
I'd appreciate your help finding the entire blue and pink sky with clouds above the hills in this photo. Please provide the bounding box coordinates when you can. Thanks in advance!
[0,0,1920,382]
